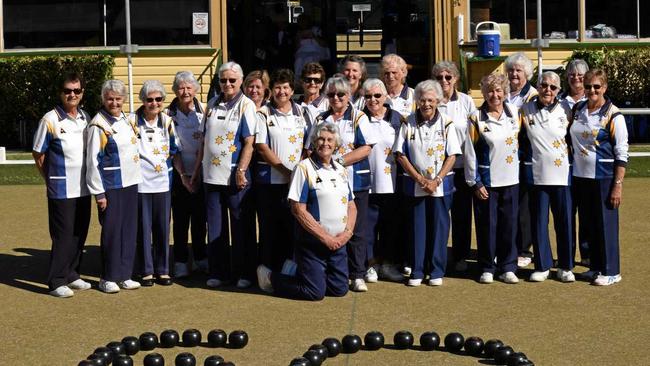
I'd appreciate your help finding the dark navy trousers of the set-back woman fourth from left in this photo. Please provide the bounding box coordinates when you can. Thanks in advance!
[172,171,207,263]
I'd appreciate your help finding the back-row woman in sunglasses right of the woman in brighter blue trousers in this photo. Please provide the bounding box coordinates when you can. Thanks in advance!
[431,61,476,272]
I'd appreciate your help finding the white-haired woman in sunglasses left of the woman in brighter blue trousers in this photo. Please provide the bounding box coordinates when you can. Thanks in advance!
[363,78,404,282]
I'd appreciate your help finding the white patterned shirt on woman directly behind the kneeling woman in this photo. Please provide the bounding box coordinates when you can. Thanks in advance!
[308,104,377,191]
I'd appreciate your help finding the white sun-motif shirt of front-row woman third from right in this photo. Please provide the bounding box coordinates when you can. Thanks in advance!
[465,103,519,187]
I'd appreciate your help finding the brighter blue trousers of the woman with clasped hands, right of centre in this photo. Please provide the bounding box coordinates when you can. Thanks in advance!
[407,194,452,279]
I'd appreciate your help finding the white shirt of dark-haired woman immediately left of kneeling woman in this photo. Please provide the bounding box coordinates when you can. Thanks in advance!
[255,102,307,184]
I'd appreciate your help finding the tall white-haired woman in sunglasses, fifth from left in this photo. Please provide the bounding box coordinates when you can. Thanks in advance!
[192,62,257,288]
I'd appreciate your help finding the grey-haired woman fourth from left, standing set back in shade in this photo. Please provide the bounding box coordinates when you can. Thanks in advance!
[165,71,208,278]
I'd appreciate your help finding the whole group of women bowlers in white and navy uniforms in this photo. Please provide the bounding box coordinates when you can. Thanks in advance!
[34,53,627,300]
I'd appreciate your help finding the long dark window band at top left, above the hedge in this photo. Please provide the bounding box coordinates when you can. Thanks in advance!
[2,0,210,49]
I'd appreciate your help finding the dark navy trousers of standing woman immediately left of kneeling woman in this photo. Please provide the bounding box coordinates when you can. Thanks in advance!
[255,184,295,271]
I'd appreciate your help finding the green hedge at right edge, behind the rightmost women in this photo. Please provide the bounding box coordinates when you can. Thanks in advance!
[560,47,650,108]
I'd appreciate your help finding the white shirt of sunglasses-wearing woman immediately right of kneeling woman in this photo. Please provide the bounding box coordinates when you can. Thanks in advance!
[364,105,403,194]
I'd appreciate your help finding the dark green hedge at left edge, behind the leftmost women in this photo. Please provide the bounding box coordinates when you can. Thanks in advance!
[0,55,115,148]
